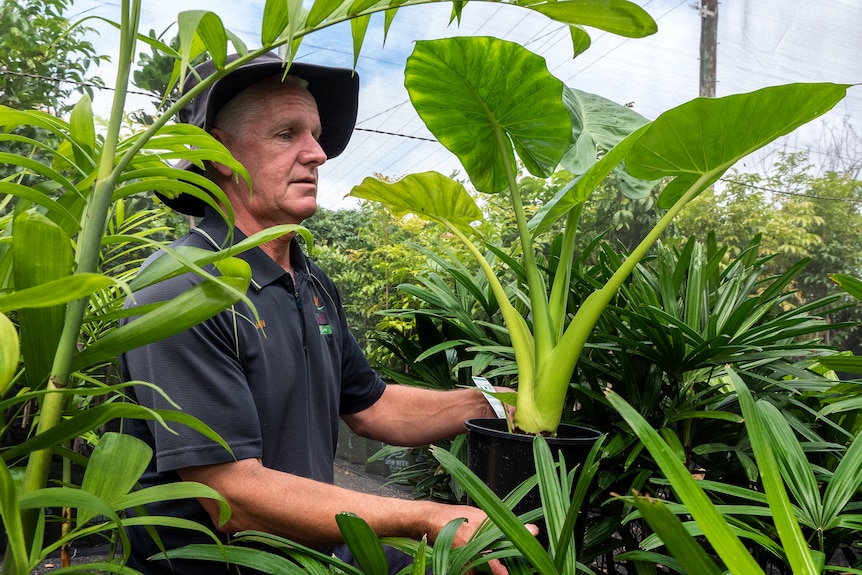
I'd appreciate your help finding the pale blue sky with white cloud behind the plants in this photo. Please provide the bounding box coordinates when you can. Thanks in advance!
[68,0,862,209]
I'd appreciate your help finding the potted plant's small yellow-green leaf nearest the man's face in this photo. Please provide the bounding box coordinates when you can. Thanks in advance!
[350,172,482,233]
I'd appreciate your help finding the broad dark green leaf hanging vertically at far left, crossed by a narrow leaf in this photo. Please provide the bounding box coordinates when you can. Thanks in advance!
[12,212,74,387]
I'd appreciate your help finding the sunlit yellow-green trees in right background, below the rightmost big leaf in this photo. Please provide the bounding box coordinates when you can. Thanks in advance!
[676,153,862,351]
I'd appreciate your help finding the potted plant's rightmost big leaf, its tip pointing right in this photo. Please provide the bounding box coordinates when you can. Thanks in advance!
[626,83,850,208]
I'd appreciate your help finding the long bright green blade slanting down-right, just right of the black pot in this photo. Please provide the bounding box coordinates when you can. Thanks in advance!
[606,391,763,574]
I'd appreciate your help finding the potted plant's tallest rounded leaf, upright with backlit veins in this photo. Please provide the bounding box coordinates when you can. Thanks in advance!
[404,37,572,193]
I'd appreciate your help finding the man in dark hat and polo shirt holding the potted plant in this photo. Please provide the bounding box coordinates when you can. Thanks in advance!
[122,54,528,573]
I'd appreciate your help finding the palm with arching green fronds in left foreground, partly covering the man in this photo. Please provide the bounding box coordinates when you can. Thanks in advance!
[0,0,655,573]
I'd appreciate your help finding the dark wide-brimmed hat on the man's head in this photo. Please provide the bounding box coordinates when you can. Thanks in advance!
[157,52,359,216]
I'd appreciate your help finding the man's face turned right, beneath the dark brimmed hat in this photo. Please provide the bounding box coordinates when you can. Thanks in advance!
[213,81,326,231]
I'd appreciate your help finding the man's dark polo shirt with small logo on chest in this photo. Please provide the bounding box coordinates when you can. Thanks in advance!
[120,212,385,573]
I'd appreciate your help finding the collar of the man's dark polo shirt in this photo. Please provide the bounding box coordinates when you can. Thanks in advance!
[192,206,308,290]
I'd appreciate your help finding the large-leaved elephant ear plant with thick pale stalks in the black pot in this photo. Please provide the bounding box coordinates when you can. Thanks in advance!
[351,37,849,435]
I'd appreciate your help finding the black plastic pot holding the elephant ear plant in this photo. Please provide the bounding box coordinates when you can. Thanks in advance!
[465,419,601,514]
